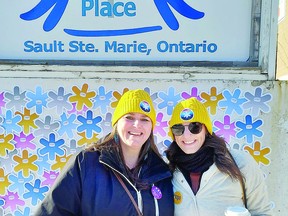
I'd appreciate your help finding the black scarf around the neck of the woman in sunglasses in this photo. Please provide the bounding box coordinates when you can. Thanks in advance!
[173,144,214,173]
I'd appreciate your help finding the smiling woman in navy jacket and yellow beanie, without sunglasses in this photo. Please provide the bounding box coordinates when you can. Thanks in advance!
[36,89,174,216]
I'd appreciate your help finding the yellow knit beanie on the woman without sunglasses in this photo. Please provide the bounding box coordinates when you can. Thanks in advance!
[112,89,156,128]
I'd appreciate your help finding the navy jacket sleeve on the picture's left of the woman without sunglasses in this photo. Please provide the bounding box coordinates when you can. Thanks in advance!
[35,152,84,216]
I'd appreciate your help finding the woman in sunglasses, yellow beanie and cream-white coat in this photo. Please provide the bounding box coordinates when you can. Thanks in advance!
[166,98,272,216]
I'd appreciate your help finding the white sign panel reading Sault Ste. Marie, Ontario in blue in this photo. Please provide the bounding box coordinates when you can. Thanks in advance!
[0,0,252,61]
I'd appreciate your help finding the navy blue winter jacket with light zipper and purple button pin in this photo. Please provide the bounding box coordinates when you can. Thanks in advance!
[35,150,174,216]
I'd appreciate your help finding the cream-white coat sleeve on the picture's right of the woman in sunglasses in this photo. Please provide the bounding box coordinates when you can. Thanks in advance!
[235,152,273,216]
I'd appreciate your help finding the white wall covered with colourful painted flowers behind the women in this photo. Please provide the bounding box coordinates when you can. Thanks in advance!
[0,78,288,216]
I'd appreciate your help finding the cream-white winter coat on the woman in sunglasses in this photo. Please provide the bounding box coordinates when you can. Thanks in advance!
[173,150,272,216]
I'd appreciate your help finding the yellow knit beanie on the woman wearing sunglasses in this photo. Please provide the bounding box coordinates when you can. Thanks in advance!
[169,98,213,135]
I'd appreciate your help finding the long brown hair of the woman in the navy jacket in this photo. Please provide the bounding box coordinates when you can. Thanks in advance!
[86,123,161,189]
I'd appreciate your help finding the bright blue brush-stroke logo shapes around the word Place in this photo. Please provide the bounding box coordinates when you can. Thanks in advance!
[20,0,205,37]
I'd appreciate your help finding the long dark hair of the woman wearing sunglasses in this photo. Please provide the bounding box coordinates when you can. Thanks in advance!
[166,133,242,181]
